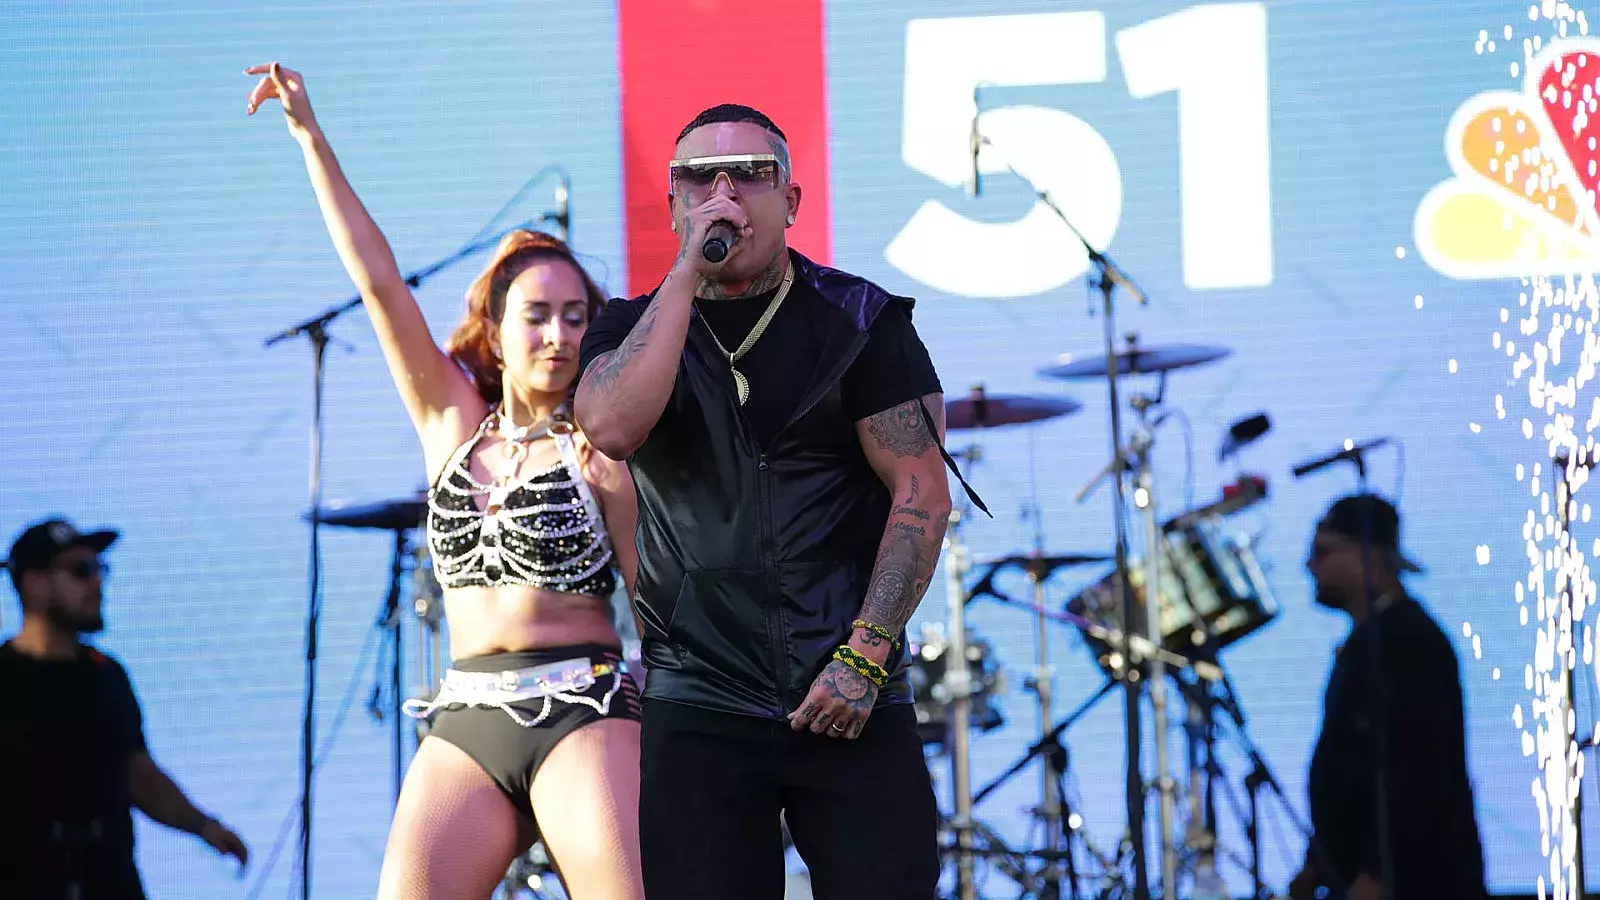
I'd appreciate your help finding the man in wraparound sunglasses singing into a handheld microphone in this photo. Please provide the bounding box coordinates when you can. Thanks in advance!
[576,104,950,900]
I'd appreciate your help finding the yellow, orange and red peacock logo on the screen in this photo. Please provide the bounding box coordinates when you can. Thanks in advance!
[1414,38,1600,279]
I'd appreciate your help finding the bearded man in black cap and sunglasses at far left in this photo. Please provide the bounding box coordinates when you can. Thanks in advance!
[0,519,250,900]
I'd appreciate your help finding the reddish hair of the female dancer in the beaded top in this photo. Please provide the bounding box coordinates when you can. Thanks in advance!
[445,229,606,407]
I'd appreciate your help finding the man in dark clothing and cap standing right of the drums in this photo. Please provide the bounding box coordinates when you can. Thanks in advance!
[1290,495,1486,900]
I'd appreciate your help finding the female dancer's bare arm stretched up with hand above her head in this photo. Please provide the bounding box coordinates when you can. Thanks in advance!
[245,62,482,434]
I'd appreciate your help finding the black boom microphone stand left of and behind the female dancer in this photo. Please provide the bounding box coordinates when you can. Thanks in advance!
[264,215,555,900]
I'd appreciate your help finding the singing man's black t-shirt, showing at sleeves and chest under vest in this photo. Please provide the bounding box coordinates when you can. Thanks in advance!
[579,269,941,445]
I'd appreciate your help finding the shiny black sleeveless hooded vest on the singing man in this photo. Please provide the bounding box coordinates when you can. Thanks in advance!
[629,251,912,719]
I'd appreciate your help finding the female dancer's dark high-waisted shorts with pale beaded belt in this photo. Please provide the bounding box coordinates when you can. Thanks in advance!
[427,644,638,820]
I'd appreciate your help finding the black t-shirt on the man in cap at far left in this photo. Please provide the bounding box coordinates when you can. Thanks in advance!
[0,644,146,900]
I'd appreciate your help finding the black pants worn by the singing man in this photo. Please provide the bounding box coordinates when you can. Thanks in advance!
[638,701,939,900]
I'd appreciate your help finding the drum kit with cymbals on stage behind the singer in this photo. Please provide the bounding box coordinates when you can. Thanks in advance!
[928,335,1278,900]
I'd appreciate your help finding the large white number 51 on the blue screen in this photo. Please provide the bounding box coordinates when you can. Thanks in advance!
[885,3,1272,298]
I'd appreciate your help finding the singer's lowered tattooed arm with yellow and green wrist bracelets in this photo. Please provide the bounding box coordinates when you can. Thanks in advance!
[789,394,950,738]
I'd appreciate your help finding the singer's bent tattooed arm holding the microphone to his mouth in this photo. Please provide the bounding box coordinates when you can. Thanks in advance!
[573,194,749,460]
